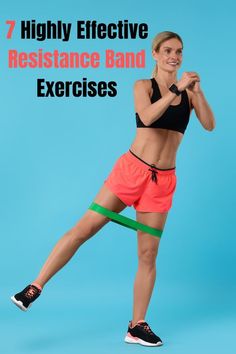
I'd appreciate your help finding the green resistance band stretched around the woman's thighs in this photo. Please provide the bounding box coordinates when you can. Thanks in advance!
[89,203,162,237]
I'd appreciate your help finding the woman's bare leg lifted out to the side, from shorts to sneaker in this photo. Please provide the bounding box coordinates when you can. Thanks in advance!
[33,184,126,287]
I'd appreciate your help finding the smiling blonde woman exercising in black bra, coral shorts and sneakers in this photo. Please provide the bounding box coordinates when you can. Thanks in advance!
[11,32,215,346]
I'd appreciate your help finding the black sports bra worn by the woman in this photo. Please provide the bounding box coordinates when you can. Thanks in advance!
[136,78,190,134]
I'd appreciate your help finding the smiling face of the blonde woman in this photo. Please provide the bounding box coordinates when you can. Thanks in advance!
[152,38,183,73]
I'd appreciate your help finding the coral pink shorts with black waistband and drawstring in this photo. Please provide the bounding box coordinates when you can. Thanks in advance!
[104,150,176,213]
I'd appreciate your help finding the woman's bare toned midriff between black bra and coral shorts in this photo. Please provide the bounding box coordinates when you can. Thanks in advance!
[130,128,183,169]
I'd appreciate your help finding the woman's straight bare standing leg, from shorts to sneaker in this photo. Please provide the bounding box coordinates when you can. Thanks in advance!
[132,211,168,325]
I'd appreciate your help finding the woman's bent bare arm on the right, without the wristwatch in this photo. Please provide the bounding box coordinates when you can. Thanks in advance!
[188,82,216,131]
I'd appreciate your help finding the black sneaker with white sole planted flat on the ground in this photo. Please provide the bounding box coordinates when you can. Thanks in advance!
[125,320,163,347]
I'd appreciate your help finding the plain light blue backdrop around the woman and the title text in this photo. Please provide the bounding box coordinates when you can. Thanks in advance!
[0,0,236,354]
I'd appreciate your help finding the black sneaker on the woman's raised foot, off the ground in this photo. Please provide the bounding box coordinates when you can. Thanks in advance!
[11,284,41,311]
